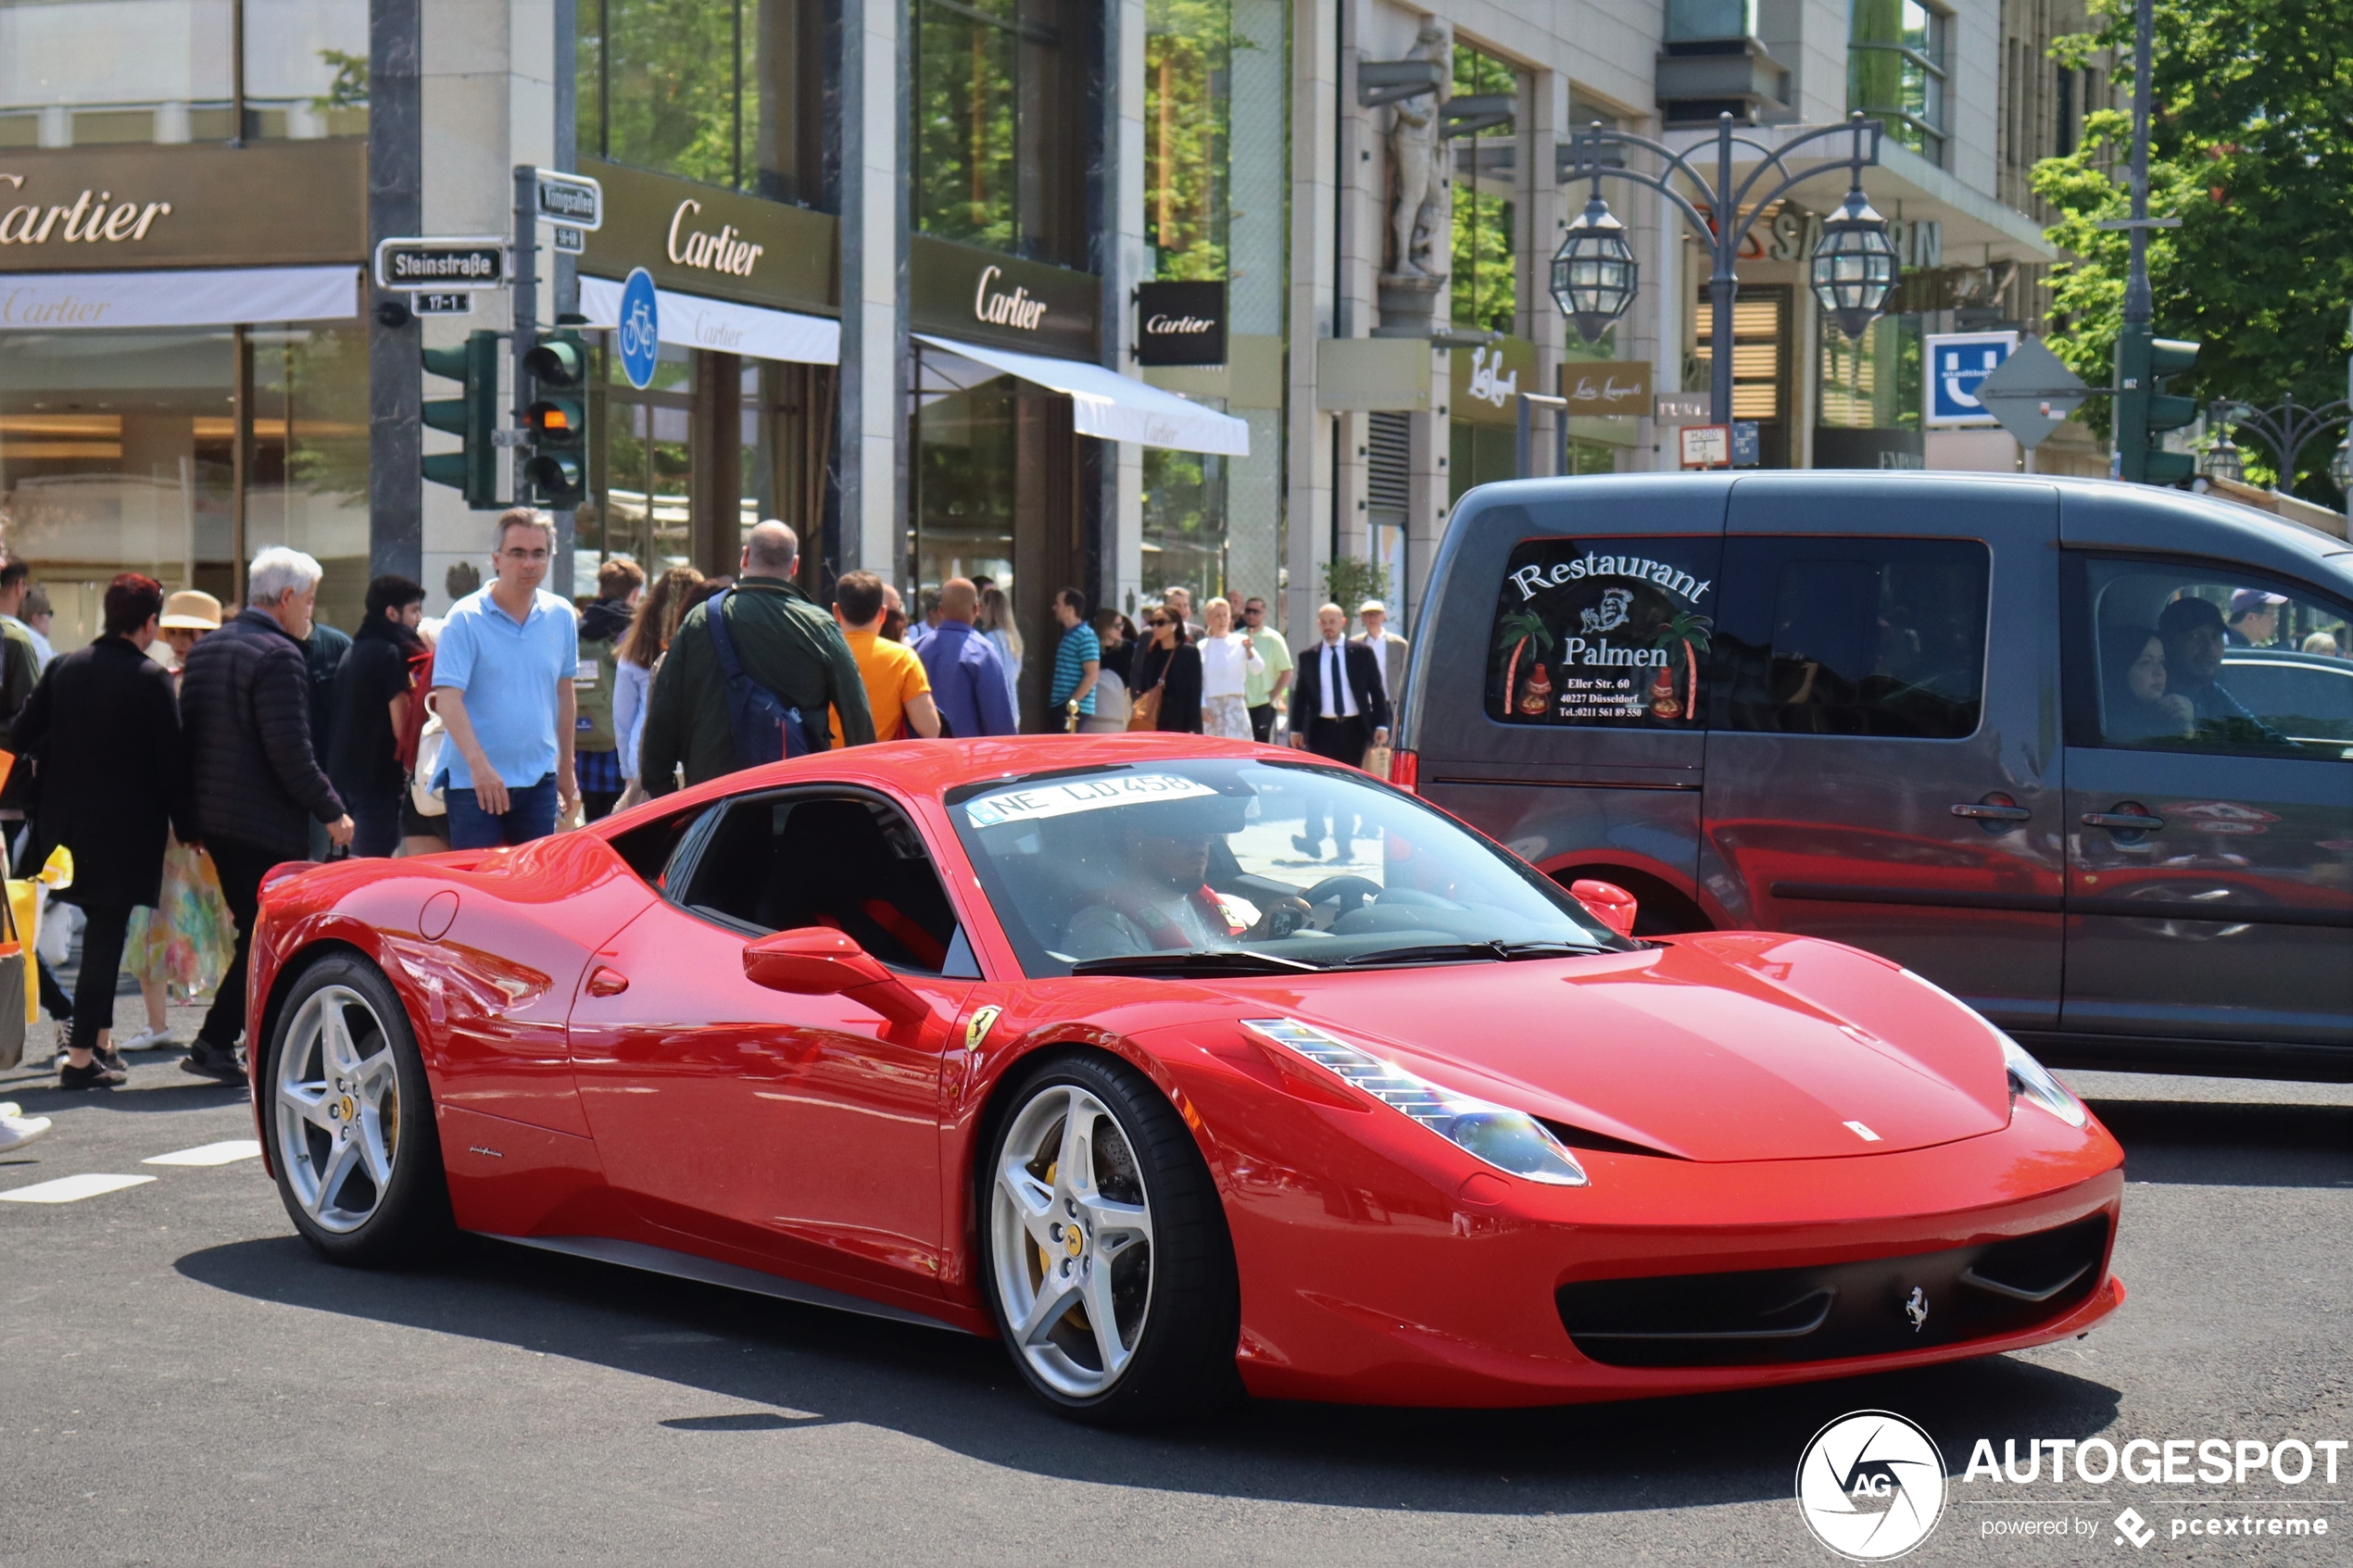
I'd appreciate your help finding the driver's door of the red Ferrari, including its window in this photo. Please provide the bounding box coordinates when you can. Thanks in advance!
[570,790,979,1296]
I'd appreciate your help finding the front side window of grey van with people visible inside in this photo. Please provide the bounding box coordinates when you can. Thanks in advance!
[2069,558,2353,759]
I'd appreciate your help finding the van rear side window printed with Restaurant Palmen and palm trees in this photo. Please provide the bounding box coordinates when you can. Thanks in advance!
[1487,533,1722,729]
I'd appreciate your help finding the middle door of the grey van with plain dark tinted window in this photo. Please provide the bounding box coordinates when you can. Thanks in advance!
[1701,475,2064,1043]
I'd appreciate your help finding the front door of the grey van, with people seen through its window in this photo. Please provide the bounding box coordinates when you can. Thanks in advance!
[2061,550,2353,1051]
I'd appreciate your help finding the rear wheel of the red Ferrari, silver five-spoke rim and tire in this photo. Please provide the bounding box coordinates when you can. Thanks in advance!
[258,952,454,1267]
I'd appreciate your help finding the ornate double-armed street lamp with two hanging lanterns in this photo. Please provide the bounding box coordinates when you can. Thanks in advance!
[1551,113,1896,425]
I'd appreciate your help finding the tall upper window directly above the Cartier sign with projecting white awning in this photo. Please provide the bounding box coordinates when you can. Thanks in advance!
[915,0,1094,268]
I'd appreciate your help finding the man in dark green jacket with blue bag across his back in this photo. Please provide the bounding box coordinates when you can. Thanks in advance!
[637,517,875,795]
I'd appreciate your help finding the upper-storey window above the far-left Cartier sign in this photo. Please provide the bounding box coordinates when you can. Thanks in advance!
[0,0,367,150]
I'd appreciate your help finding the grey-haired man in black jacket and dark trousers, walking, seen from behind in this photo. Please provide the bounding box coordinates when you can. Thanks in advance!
[179,546,350,1084]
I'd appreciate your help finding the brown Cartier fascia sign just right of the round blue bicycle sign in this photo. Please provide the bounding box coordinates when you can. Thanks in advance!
[581,157,840,315]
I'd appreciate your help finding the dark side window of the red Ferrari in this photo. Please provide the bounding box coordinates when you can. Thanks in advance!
[680,795,979,978]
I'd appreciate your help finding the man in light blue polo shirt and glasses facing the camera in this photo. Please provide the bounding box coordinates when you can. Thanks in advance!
[433,506,581,848]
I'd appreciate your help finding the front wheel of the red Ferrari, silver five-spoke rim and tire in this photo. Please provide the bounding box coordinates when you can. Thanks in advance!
[975,1053,1242,1427]
